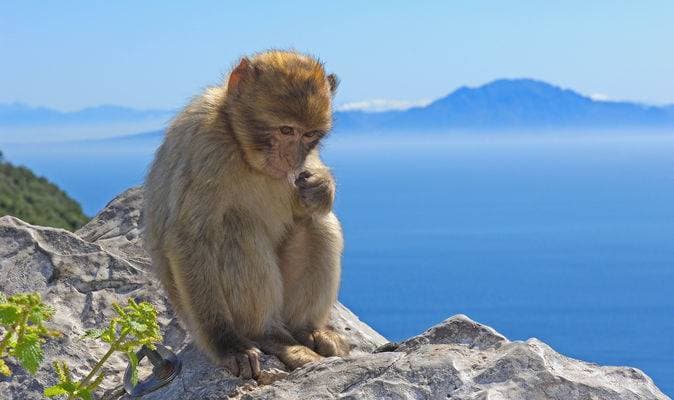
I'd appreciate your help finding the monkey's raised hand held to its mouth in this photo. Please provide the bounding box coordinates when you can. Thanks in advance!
[295,169,335,214]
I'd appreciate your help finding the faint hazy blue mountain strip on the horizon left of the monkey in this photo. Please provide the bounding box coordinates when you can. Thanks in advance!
[0,103,174,126]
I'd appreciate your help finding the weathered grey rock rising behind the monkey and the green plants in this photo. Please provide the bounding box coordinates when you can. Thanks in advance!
[0,188,386,400]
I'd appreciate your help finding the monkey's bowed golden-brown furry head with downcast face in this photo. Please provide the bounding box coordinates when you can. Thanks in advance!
[226,51,338,178]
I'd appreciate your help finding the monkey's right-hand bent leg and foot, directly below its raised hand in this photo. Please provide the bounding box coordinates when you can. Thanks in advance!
[280,213,350,357]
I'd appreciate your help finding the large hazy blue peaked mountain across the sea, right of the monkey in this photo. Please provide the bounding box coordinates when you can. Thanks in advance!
[335,79,674,131]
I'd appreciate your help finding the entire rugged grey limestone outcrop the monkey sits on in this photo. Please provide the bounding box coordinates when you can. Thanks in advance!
[0,188,668,400]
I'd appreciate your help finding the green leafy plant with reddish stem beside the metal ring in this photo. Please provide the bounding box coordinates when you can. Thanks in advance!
[44,299,162,400]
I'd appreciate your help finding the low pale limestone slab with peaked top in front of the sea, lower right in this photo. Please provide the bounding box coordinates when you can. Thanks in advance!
[247,315,668,400]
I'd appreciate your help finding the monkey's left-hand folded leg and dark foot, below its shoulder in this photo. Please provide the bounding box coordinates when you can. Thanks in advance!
[169,214,282,378]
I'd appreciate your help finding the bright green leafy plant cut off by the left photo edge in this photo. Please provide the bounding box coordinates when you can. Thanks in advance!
[0,293,59,376]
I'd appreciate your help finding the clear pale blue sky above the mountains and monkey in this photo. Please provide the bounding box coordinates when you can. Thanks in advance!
[0,0,674,111]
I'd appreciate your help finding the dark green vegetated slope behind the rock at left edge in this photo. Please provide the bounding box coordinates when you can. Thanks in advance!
[0,152,89,231]
